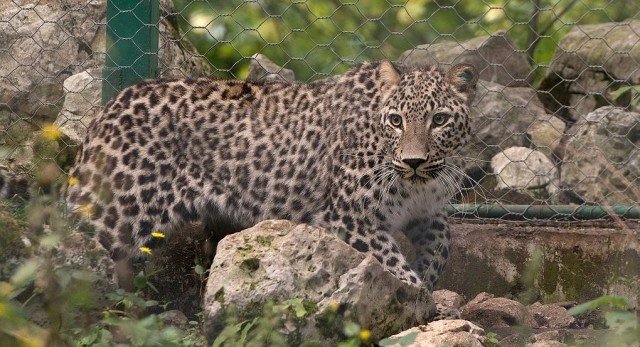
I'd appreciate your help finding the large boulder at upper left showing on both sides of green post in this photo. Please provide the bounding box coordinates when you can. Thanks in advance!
[0,0,212,123]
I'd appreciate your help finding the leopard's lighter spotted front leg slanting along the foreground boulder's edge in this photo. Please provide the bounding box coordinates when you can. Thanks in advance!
[337,226,422,286]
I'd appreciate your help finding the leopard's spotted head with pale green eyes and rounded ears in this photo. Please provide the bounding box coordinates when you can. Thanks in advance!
[380,64,477,182]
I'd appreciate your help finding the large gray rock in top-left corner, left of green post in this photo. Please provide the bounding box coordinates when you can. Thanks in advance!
[0,0,104,119]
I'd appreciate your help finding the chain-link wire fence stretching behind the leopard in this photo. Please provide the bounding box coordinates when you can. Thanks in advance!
[0,0,640,224]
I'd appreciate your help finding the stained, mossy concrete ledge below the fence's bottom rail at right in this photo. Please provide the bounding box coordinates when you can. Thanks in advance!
[438,219,640,307]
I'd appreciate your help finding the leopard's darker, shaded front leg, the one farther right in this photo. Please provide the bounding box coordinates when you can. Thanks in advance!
[403,213,451,291]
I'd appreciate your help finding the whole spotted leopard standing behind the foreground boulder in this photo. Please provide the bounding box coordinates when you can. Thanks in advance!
[65,60,478,291]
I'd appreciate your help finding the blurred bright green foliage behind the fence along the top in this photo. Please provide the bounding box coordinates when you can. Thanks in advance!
[173,0,640,81]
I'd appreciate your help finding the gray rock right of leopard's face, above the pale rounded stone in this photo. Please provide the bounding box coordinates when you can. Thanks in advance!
[460,81,550,172]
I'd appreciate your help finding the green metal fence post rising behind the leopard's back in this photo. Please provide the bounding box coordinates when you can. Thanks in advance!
[102,0,160,104]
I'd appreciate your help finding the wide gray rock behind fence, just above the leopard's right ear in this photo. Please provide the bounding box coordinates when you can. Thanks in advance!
[398,32,534,87]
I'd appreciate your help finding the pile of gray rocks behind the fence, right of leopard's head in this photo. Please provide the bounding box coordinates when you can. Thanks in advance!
[399,20,640,205]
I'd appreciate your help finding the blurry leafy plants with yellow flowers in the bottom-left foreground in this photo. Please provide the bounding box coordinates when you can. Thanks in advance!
[0,170,206,346]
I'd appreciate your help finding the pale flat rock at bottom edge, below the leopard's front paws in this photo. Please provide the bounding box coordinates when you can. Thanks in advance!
[386,319,487,347]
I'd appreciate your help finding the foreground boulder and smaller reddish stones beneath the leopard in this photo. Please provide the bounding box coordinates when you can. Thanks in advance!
[199,221,616,346]
